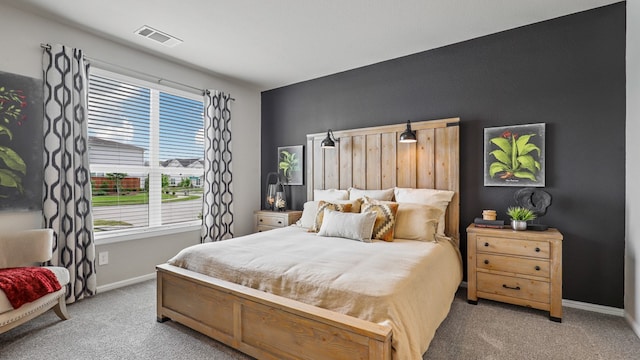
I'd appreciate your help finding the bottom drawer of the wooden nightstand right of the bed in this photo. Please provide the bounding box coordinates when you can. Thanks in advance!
[477,272,550,304]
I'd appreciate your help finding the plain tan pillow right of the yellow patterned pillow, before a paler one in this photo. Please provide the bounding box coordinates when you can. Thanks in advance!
[394,203,443,241]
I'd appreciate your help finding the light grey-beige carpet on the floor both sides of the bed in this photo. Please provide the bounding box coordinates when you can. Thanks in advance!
[0,281,640,360]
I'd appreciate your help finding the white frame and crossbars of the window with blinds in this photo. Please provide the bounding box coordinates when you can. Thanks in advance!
[89,67,204,245]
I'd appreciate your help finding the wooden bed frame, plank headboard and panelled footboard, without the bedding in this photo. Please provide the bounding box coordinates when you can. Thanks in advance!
[156,118,460,360]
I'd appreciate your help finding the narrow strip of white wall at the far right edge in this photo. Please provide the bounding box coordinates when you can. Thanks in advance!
[624,0,640,336]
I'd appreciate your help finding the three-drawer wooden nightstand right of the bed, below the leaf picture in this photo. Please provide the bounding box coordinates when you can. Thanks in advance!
[467,224,562,322]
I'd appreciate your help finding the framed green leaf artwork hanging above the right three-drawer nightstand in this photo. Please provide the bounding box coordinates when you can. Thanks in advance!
[484,123,545,187]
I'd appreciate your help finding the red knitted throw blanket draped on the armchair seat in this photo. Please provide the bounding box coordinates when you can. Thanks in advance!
[0,267,61,309]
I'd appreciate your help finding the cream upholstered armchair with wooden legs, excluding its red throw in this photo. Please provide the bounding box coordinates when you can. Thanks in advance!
[0,229,69,334]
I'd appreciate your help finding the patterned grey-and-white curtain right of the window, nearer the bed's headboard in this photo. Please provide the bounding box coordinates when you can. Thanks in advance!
[201,90,233,242]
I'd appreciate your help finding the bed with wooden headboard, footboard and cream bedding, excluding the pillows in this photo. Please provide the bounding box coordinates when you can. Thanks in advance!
[157,119,462,359]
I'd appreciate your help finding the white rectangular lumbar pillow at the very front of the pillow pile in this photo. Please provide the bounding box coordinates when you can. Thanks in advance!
[317,209,376,242]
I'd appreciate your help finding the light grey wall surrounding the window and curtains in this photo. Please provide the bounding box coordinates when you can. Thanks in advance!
[0,4,260,286]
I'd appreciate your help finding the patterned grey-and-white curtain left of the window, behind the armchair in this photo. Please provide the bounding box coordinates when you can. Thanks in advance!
[42,45,96,303]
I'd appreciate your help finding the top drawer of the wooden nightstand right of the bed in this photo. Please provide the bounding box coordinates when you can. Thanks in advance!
[476,236,549,259]
